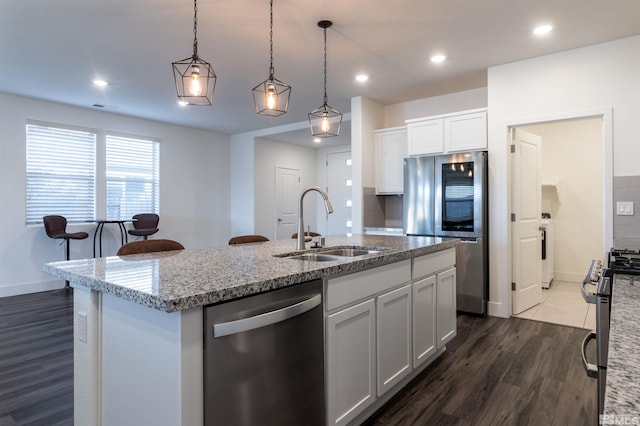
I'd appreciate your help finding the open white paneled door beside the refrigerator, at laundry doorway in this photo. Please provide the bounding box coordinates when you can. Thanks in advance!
[511,129,542,314]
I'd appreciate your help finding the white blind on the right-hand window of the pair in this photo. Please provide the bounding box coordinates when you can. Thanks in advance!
[106,135,160,220]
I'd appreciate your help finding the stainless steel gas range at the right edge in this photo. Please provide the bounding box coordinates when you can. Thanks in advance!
[582,249,640,415]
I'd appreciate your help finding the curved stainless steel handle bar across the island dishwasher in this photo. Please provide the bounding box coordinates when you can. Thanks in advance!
[213,293,322,338]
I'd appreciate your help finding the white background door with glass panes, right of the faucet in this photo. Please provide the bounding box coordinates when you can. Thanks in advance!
[326,152,352,235]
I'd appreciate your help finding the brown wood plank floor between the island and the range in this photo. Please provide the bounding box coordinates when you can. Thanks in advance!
[367,315,598,426]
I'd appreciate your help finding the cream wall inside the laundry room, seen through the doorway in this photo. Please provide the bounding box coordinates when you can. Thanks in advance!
[521,118,603,282]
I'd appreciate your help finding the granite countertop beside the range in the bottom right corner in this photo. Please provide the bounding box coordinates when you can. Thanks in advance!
[604,275,640,418]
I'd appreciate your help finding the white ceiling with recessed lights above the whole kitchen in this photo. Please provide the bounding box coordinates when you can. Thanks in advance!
[0,0,640,143]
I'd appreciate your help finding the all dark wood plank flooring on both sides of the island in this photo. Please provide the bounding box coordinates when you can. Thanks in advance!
[0,293,597,426]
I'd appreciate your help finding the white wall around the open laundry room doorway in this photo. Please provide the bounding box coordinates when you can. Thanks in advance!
[488,36,640,317]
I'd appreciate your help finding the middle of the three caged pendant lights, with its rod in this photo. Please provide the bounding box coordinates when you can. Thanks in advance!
[252,0,291,117]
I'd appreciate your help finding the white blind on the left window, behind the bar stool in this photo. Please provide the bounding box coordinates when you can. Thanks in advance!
[26,124,96,224]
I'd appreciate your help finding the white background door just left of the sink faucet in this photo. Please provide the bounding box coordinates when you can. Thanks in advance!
[276,167,302,240]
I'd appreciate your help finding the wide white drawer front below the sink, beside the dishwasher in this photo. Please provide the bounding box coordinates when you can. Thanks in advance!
[326,260,410,311]
